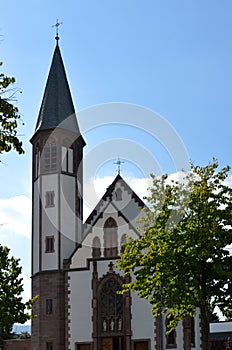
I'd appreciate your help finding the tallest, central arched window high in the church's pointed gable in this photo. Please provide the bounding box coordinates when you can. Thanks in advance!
[104,217,118,257]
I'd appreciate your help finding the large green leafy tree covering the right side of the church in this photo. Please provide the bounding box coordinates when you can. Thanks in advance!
[118,160,232,350]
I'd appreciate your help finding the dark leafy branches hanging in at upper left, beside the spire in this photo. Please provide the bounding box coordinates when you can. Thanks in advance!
[0,62,24,154]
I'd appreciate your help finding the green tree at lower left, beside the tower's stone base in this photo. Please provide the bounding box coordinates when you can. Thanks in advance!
[0,245,35,334]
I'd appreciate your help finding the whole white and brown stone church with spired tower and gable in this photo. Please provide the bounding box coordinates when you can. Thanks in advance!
[31,35,201,350]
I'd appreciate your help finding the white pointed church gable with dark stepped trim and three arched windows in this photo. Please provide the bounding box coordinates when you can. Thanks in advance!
[71,175,144,268]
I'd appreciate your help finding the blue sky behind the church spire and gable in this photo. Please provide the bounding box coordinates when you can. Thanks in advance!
[0,0,232,306]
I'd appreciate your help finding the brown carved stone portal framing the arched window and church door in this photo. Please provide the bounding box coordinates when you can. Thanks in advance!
[93,261,131,350]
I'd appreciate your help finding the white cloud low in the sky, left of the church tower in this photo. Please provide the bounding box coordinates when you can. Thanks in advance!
[0,195,31,238]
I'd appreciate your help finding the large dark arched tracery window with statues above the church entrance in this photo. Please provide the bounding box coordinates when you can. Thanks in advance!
[99,277,123,333]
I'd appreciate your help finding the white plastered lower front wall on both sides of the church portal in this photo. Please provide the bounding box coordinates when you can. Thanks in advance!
[69,259,154,350]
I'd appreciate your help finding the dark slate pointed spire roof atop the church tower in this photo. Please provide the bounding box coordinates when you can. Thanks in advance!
[36,40,80,133]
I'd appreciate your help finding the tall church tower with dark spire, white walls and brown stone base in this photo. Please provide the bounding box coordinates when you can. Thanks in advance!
[31,36,85,350]
